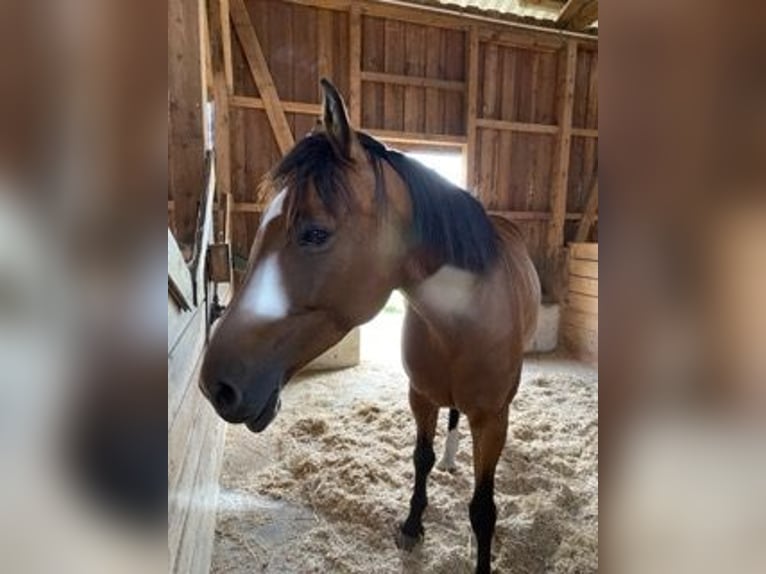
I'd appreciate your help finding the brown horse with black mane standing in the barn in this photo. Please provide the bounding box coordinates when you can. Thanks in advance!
[201,80,540,572]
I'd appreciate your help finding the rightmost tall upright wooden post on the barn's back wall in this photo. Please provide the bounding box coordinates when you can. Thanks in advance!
[546,40,577,265]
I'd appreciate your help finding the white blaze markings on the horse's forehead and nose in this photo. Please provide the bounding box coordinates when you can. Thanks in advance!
[243,190,290,320]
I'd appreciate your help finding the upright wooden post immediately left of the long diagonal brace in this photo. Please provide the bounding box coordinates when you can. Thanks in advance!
[207,0,231,199]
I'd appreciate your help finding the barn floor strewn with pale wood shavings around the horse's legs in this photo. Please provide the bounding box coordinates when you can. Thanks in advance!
[212,302,598,574]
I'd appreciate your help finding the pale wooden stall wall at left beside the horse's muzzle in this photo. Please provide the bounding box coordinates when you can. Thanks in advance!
[168,164,225,574]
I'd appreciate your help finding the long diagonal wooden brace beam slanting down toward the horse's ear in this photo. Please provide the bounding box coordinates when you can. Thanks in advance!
[229,0,295,154]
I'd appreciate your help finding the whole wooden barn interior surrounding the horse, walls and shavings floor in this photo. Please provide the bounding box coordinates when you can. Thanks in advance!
[168,0,598,574]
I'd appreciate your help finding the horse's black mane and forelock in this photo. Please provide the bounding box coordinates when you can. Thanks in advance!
[270,132,498,273]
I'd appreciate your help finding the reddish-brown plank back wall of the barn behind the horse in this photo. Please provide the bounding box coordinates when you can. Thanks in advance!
[194,0,598,294]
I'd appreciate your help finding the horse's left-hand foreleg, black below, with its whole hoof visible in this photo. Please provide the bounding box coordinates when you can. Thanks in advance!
[396,387,439,550]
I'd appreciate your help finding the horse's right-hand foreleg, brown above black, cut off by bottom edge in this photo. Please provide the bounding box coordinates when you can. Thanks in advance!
[469,406,508,574]
